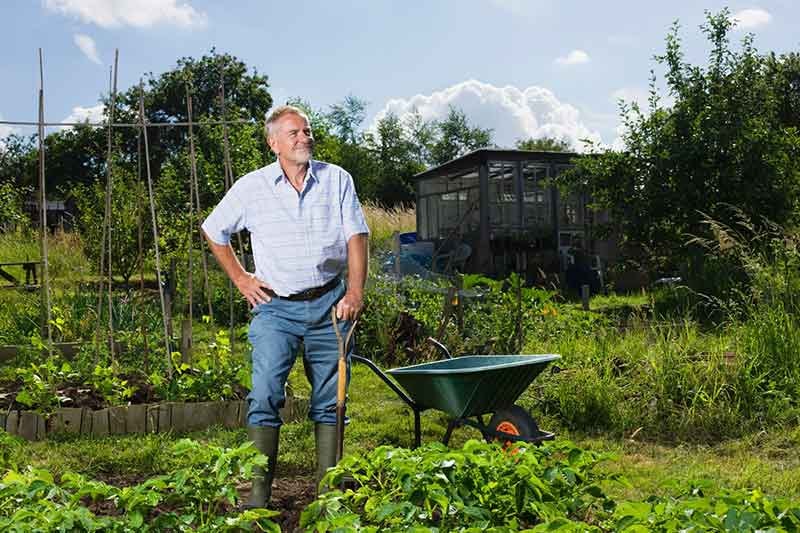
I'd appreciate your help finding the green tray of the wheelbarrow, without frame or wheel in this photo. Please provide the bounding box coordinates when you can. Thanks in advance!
[388,354,560,419]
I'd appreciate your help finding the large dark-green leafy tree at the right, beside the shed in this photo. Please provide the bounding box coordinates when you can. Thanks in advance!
[570,10,800,275]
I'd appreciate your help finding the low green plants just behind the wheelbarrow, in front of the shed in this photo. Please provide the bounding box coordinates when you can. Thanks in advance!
[356,274,608,364]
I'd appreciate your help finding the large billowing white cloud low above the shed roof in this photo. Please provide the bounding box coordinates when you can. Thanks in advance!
[371,80,600,150]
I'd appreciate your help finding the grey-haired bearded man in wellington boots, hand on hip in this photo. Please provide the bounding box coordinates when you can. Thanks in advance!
[203,106,369,507]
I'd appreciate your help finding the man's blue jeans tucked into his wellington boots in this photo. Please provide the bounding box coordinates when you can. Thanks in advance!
[247,282,354,427]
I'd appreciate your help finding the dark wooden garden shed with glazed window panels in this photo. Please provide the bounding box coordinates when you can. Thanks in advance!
[415,149,618,279]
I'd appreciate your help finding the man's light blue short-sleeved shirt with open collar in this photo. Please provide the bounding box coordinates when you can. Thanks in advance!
[203,161,369,296]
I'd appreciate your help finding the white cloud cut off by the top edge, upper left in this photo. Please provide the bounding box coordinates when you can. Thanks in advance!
[44,0,208,28]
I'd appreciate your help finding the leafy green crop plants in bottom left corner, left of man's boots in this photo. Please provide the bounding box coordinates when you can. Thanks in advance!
[0,440,280,532]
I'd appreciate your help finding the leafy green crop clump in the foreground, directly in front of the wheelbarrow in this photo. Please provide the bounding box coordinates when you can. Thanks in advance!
[301,441,616,532]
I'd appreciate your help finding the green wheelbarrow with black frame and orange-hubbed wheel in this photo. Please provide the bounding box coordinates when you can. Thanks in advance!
[351,339,560,447]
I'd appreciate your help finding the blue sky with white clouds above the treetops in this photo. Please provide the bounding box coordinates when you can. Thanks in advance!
[0,0,800,149]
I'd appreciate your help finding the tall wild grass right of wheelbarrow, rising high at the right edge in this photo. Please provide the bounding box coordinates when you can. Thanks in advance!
[526,212,800,441]
